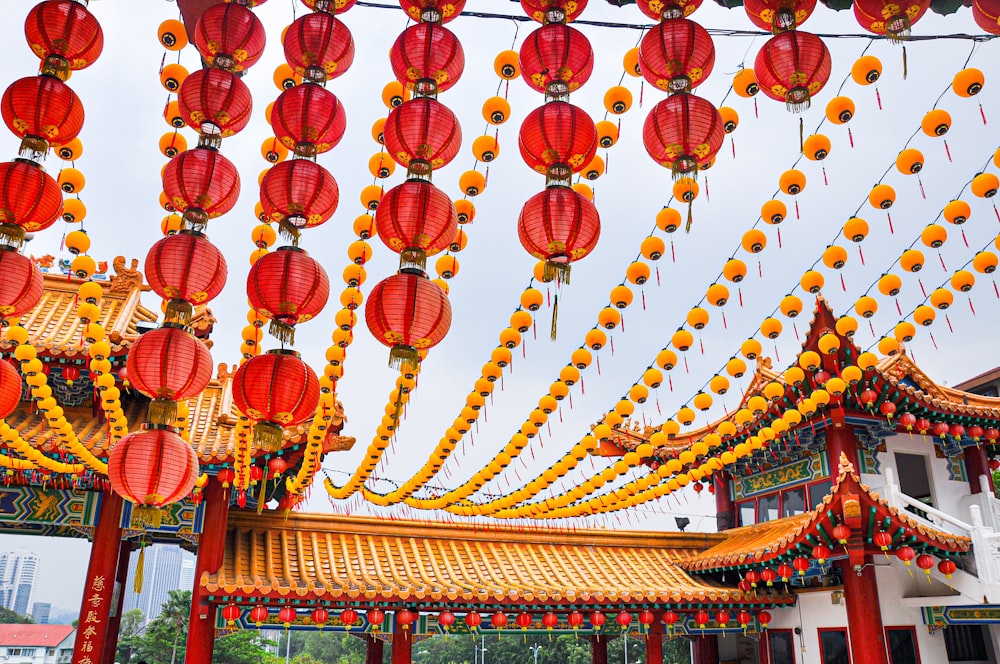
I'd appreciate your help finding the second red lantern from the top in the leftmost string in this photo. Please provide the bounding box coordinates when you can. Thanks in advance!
[0,75,83,151]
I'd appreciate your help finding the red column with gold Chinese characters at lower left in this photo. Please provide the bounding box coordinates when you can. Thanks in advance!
[73,491,122,664]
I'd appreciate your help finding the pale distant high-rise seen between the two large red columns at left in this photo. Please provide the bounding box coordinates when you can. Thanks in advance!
[122,544,194,623]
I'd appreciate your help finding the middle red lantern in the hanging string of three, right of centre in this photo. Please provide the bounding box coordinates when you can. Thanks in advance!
[639,18,715,93]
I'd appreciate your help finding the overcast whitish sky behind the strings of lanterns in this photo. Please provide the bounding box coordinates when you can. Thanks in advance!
[0,0,1000,607]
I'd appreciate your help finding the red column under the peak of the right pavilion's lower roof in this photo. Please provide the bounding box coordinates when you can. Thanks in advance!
[837,559,889,664]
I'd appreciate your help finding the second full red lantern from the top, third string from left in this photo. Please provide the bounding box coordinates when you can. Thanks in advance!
[271,85,347,157]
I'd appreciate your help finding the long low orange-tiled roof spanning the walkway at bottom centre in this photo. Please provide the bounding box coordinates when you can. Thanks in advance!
[200,512,790,607]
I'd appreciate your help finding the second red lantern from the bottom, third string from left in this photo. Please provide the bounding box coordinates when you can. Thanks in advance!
[247,247,330,343]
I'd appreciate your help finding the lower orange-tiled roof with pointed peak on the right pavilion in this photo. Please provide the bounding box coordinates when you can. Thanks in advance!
[680,455,972,571]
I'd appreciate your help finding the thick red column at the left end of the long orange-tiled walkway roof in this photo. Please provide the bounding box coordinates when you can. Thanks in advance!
[184,477,229,664]
